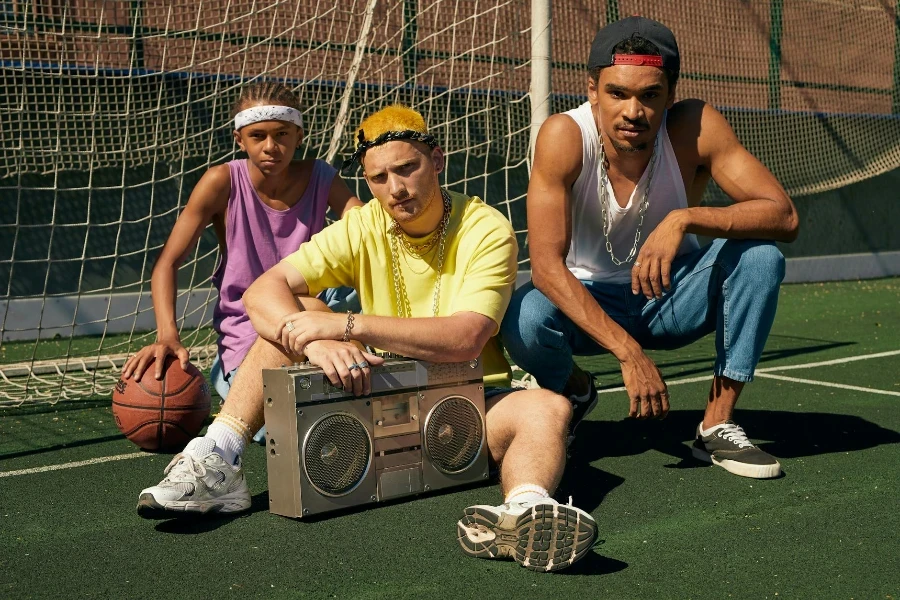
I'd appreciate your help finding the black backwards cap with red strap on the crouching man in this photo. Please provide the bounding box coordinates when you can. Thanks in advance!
[588,17,681,74]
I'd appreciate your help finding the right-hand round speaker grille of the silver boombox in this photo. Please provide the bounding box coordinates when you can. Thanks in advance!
[425,396,484,474]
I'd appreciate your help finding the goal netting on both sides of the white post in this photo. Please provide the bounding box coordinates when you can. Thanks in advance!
[0,0,900,406]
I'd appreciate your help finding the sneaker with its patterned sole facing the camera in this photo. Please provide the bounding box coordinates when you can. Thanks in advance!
[456,498,597,571]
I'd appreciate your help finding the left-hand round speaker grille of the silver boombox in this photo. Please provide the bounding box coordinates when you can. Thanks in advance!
[303,413,372,496]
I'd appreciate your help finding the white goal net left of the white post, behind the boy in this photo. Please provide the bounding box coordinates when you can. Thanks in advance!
[0,0,530,406]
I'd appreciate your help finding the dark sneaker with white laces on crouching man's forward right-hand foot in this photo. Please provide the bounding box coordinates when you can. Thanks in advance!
[691,421,781,479]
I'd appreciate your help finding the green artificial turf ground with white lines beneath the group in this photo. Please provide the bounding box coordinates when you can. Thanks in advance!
[0,279,900,600]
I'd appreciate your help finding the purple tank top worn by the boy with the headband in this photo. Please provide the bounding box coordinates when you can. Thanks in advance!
[212,159,337,373]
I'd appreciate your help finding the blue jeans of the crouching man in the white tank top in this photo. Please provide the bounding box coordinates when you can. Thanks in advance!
[500,239,784,392]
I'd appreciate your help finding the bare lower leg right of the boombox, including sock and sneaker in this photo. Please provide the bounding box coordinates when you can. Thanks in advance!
[457,390,597,571]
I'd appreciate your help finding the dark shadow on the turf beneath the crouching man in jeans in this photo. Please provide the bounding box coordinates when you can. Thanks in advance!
[558,409,900,512]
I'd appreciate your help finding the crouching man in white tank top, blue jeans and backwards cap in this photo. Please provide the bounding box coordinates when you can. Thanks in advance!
[501,17,798,478]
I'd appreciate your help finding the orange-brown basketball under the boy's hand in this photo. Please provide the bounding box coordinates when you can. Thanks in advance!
[113,356,211,452]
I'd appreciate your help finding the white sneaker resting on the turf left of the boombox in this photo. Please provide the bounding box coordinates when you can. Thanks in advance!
[138,437,250,519]
